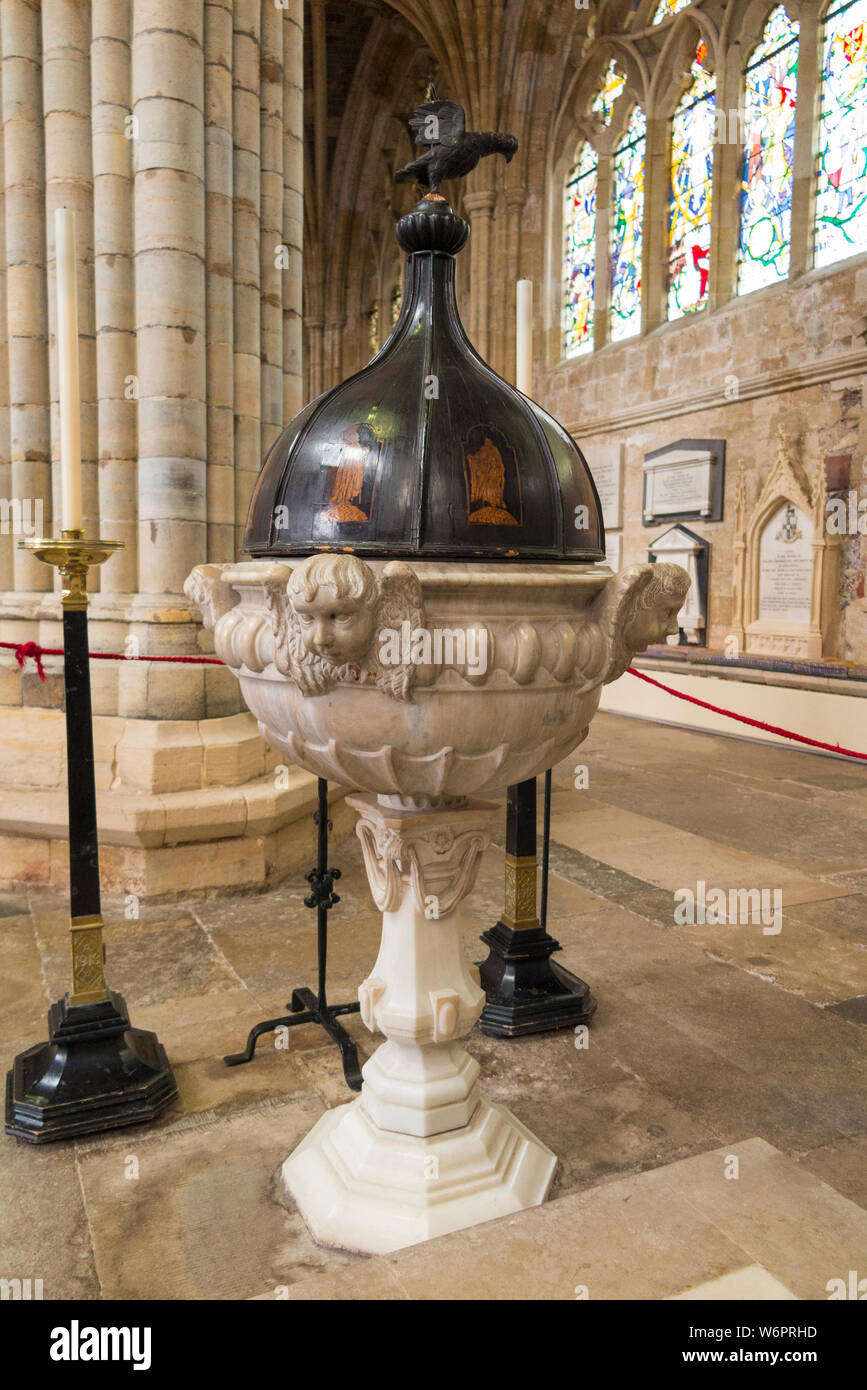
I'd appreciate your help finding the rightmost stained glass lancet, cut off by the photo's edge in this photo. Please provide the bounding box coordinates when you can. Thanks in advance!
[816,0,867,265]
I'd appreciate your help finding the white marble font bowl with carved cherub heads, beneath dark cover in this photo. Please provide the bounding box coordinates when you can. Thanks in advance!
[185,553,689,806]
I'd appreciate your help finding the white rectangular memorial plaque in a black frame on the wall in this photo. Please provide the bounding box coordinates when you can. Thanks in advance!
[642,439,725,525]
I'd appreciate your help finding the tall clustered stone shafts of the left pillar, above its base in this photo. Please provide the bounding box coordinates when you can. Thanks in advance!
[0,0,303,619]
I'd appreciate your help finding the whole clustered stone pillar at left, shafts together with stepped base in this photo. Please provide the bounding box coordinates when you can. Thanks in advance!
[0,0,309,905]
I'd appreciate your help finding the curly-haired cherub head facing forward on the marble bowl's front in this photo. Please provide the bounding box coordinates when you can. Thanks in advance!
[289,555,377,667]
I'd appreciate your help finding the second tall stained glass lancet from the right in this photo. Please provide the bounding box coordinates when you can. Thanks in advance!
[738,4,800,295]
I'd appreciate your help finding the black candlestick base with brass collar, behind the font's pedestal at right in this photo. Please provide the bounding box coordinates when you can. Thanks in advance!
[479,777,596,1038]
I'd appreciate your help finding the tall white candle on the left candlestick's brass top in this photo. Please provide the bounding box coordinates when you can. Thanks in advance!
[54,207,83,531]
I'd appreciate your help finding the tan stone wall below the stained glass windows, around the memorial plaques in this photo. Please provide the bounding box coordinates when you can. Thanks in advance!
[538,251,867,666]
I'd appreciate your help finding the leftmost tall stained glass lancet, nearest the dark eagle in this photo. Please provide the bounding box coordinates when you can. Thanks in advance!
[563,145,597,357]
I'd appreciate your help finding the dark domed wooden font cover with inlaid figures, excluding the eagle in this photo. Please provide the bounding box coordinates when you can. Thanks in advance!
[245,196,604,562]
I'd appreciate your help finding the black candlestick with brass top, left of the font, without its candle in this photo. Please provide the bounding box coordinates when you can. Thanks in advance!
[6,531,178,1144]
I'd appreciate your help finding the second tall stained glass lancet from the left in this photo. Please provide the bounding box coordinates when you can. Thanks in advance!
[610,106,647,342]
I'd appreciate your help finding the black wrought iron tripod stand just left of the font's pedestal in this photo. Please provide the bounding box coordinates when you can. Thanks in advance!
[224,777,361,1091]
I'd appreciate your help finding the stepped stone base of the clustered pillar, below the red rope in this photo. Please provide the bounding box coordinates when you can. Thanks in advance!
[0,708,353,899]
